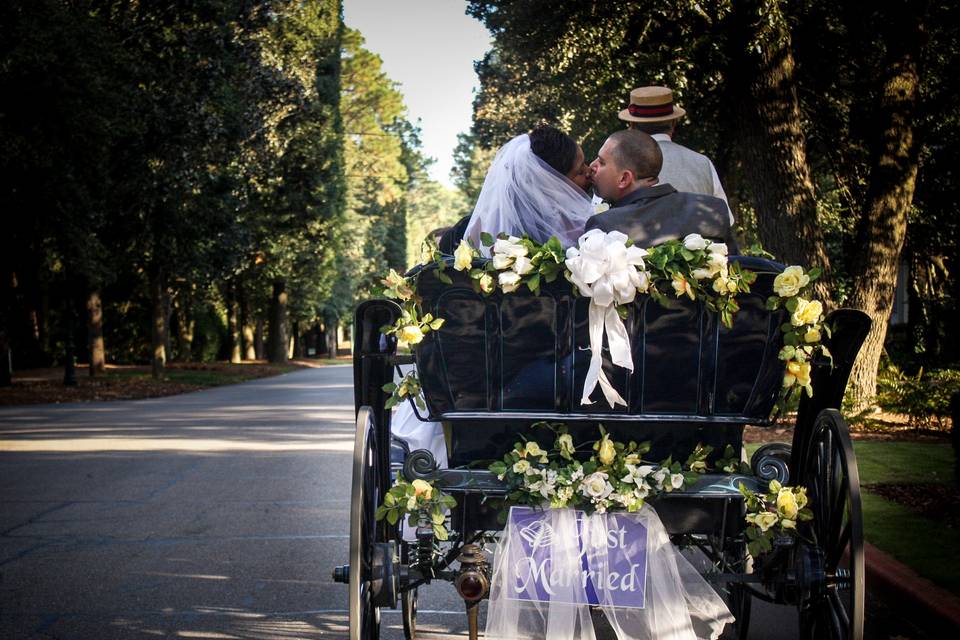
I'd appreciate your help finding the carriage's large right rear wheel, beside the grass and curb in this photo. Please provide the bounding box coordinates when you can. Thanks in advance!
[797,409,864,640]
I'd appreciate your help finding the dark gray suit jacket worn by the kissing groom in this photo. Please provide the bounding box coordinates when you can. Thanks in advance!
[584,184,739,254]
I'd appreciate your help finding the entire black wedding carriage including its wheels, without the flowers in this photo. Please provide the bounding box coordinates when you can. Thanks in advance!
[334,257,870,639]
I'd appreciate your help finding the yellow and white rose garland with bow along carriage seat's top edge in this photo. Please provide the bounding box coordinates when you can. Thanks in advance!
[382,229,831,411]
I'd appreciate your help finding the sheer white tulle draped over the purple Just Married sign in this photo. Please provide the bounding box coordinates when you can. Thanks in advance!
[485,505,733,640]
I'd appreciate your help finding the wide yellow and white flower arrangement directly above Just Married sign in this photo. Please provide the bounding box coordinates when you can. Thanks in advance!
[489,422,711,513]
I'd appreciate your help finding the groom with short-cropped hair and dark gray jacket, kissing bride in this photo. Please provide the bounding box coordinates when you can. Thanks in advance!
[584,129,738,254]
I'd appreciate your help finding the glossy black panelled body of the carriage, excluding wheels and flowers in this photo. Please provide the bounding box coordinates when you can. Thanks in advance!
[344,257,869,637]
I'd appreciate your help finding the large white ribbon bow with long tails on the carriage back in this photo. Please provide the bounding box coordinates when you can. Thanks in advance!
[565,229,650,408]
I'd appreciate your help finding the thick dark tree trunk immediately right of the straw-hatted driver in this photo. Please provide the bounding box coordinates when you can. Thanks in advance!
[728,2,831,304]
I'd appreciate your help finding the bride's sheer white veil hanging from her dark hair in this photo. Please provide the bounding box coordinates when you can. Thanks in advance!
[464,134,593,256]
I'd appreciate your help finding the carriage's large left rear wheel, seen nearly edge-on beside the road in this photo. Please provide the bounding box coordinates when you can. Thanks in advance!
[350,407,384,640]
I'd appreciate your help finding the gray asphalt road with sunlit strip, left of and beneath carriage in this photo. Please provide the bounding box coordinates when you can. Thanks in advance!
[0,366,932,640]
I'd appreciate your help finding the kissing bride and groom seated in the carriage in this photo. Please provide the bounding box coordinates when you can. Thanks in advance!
[439,125,737,256]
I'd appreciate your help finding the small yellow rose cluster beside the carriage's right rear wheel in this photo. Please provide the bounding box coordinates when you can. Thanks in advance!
[740,480,813,558]
